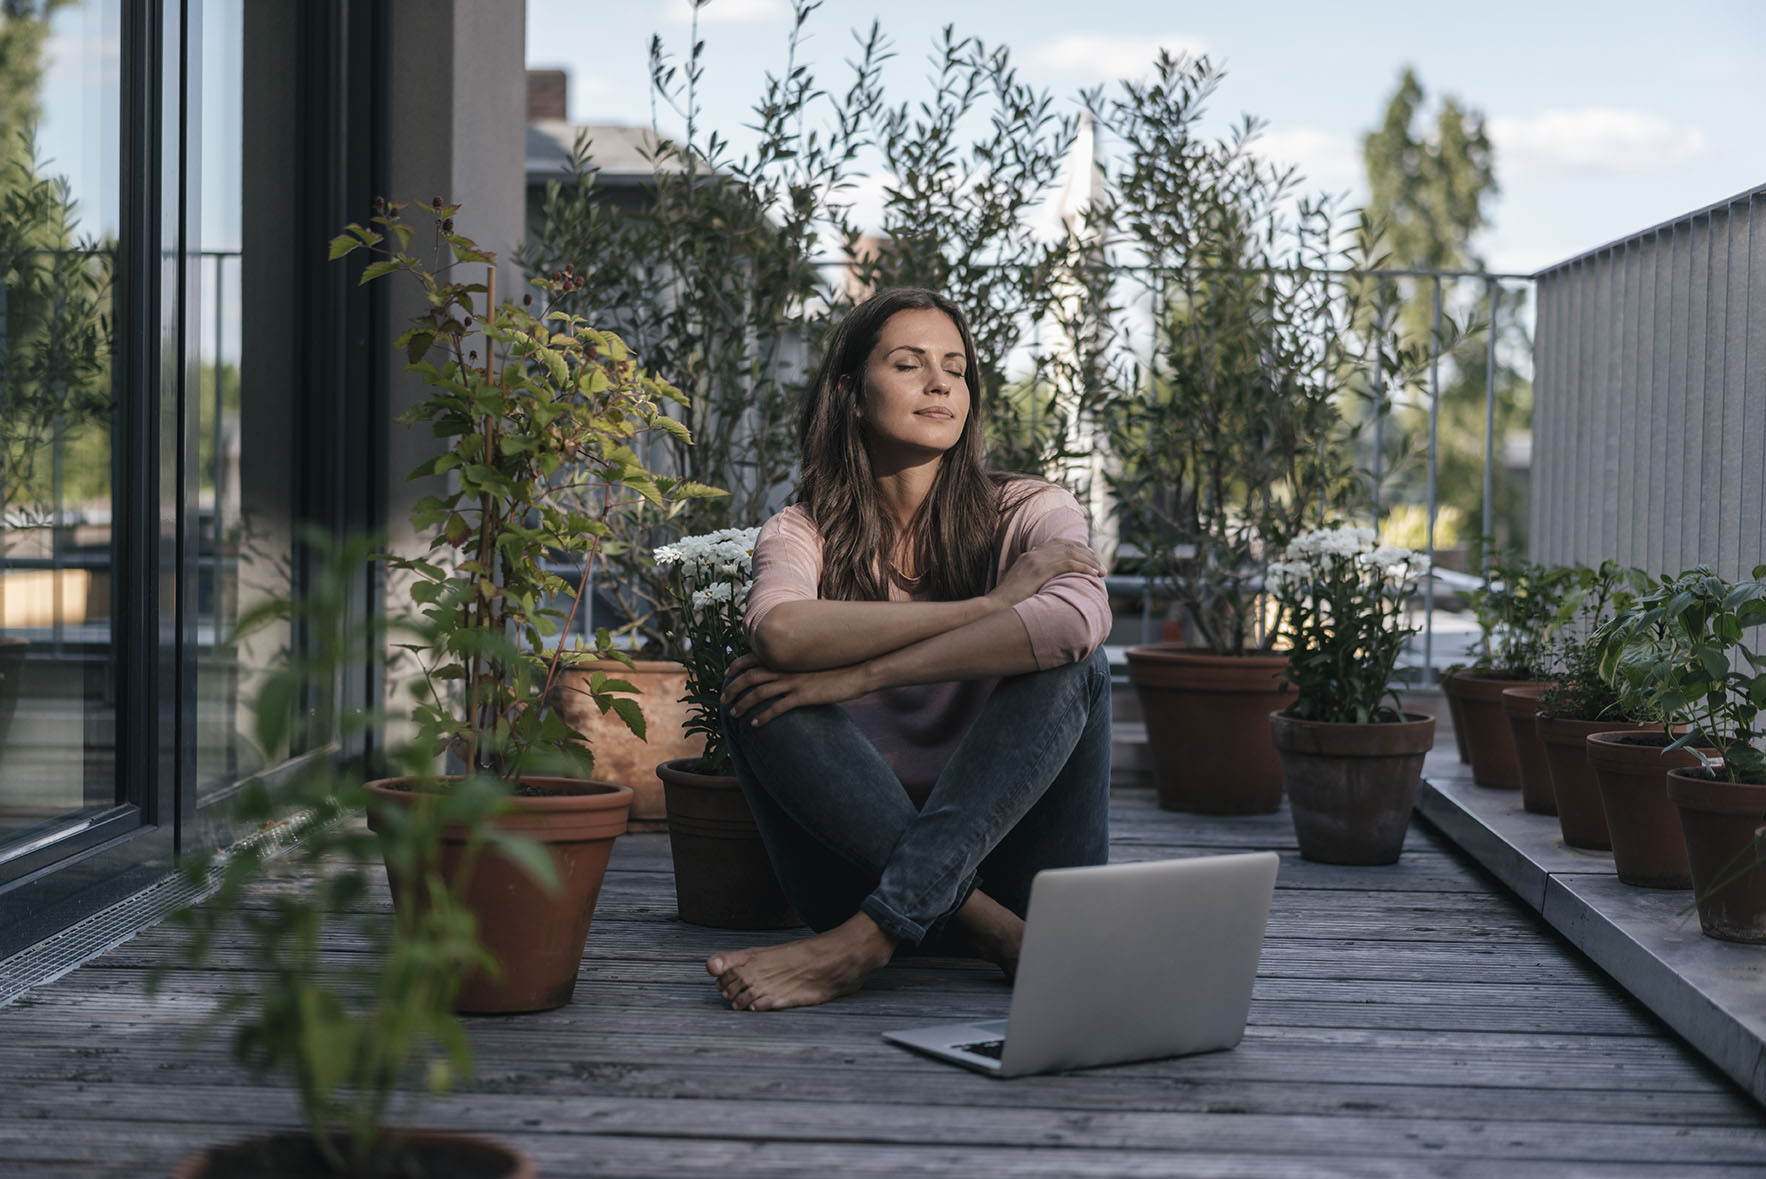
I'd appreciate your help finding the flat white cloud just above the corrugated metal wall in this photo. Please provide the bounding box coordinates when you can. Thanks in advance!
[1489,106,1711,180]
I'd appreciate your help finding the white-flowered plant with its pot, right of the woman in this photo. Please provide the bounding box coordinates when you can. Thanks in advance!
[1270,526,1434,865]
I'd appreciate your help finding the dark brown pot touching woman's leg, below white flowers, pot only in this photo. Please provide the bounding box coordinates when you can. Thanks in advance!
[657,759,804,930]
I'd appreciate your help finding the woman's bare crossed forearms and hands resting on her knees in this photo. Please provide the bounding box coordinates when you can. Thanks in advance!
[729,538,1104,725]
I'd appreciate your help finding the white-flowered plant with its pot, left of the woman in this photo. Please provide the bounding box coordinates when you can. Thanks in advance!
[655,528,802,928]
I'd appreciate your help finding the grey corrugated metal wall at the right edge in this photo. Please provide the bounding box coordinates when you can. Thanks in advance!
[1529,185,1766,577]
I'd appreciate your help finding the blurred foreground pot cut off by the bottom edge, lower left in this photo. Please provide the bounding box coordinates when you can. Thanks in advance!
[171,1130,540,1179]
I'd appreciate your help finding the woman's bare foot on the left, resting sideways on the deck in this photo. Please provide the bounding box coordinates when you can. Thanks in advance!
[705,912,895,1011]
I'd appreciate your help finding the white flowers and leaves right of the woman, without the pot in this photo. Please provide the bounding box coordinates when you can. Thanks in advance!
[1270,526,1427,724]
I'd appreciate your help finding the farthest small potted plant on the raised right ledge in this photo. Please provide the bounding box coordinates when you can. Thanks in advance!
[1441,540,1575,787]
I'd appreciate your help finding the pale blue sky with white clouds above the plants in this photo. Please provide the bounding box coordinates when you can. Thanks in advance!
[528,0,1766,274]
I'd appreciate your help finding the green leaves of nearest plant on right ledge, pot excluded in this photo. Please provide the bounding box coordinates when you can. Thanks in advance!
[1595,565,1766,785]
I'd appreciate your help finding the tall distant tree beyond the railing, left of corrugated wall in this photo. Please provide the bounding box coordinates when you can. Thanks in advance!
[1362,69,1533,542]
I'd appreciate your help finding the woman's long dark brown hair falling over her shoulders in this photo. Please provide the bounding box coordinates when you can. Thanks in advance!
[796,288,1035,602]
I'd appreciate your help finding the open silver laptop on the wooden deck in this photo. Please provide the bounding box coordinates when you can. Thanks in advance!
[883,851,1279,1077]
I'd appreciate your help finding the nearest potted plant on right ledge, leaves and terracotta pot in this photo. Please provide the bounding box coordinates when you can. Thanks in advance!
[1596,565,1766,942]
